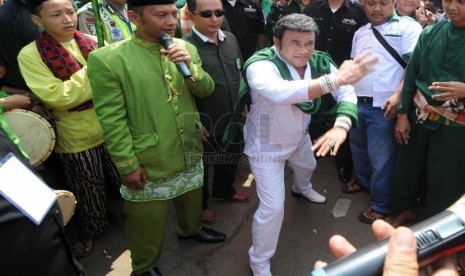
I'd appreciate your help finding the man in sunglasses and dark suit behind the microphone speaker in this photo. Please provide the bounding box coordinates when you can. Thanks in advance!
[184,0,250,223]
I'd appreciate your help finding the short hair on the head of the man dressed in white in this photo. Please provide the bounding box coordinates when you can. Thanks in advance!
[273,13,318,40]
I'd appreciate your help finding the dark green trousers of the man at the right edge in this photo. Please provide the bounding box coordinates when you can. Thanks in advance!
[390,122,465,219]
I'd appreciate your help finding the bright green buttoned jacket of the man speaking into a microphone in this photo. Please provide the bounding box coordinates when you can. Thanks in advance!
[88,35,214,181]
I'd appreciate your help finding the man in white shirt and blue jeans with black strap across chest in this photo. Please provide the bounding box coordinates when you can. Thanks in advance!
[349,0,422,223]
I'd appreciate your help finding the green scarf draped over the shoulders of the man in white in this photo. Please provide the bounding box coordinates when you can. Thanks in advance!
[222,48,358,149]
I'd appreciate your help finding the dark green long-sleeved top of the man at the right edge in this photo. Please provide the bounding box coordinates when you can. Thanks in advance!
[398,20,465,129]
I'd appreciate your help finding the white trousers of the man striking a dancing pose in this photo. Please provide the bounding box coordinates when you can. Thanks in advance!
[249,135,316,275]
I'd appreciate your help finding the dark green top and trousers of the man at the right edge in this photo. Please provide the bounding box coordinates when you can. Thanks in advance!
[390,20,465,219]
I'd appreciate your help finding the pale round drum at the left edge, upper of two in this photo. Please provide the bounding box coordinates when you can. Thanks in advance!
[3,109,56,166]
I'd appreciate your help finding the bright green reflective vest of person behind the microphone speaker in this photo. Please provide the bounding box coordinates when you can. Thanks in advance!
[78,0,135,43]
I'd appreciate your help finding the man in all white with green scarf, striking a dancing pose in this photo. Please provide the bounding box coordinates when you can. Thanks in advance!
[244,14,376,275]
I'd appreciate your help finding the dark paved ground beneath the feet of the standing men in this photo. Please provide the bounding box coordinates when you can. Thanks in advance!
[73,158,374,276]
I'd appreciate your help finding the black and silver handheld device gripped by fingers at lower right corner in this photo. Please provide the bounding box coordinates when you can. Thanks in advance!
[311,195,465,276]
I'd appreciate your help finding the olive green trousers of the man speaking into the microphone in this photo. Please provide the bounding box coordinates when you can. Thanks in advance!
[124,187,202,273]
